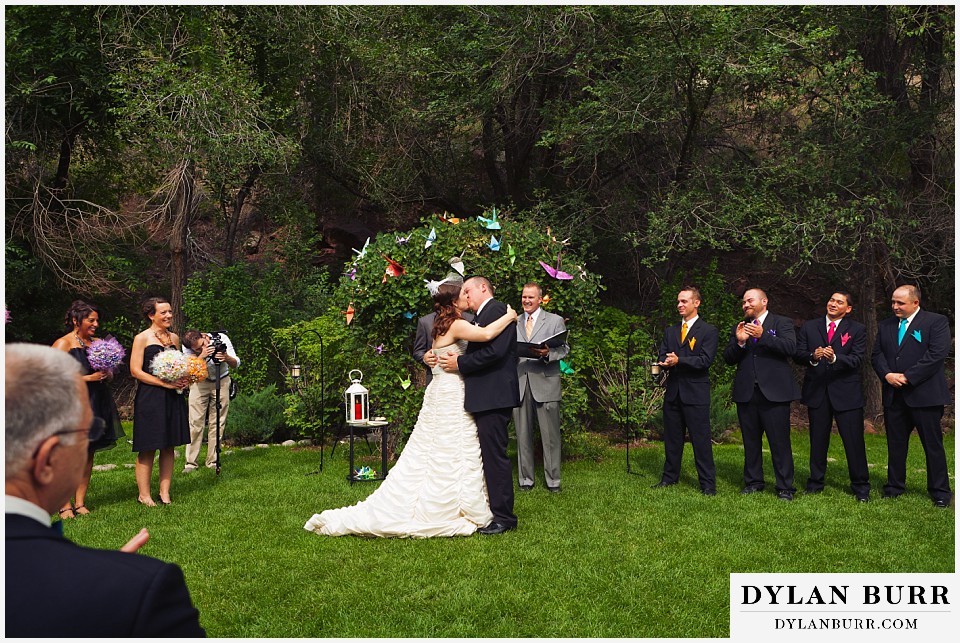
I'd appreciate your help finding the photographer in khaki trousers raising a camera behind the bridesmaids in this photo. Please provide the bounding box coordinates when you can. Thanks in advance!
[183,329,240,473]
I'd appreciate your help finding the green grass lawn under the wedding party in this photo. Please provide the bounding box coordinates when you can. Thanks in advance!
[66,432,955,638]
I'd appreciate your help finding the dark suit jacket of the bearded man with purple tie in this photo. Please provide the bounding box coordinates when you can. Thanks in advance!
[723,312,800,403]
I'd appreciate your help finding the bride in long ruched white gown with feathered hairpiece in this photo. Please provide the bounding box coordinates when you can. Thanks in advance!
[303,275,517,538]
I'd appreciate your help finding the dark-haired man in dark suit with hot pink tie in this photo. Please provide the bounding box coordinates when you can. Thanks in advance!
[794,291,870,502]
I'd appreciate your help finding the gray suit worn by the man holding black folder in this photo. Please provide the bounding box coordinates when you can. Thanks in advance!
[513,308,570,489]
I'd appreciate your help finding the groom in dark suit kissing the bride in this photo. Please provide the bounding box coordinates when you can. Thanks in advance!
[434,277,520,535]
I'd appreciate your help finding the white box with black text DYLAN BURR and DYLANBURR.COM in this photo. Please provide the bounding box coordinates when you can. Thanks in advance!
[730,574,960,643]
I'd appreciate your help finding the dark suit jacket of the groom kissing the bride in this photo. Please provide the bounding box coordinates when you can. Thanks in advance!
[457,299,520,413]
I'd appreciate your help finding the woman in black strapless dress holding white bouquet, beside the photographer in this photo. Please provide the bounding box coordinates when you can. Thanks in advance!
[130,297,190,507]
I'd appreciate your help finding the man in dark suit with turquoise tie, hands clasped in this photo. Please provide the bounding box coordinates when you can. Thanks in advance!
[873,286,953,509]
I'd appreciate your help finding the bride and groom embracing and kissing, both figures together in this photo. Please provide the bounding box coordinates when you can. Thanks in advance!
[304,273,520,538]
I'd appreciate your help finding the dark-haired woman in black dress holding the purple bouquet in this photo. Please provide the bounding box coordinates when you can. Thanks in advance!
[53,299,124,518]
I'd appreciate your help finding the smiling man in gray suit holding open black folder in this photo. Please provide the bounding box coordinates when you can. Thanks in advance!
[513,282,570,493]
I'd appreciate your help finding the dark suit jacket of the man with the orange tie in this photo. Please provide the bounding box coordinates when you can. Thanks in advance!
[660,317,720,404]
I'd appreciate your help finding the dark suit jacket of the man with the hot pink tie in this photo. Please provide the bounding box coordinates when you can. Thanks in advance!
[794,315,867,411]
